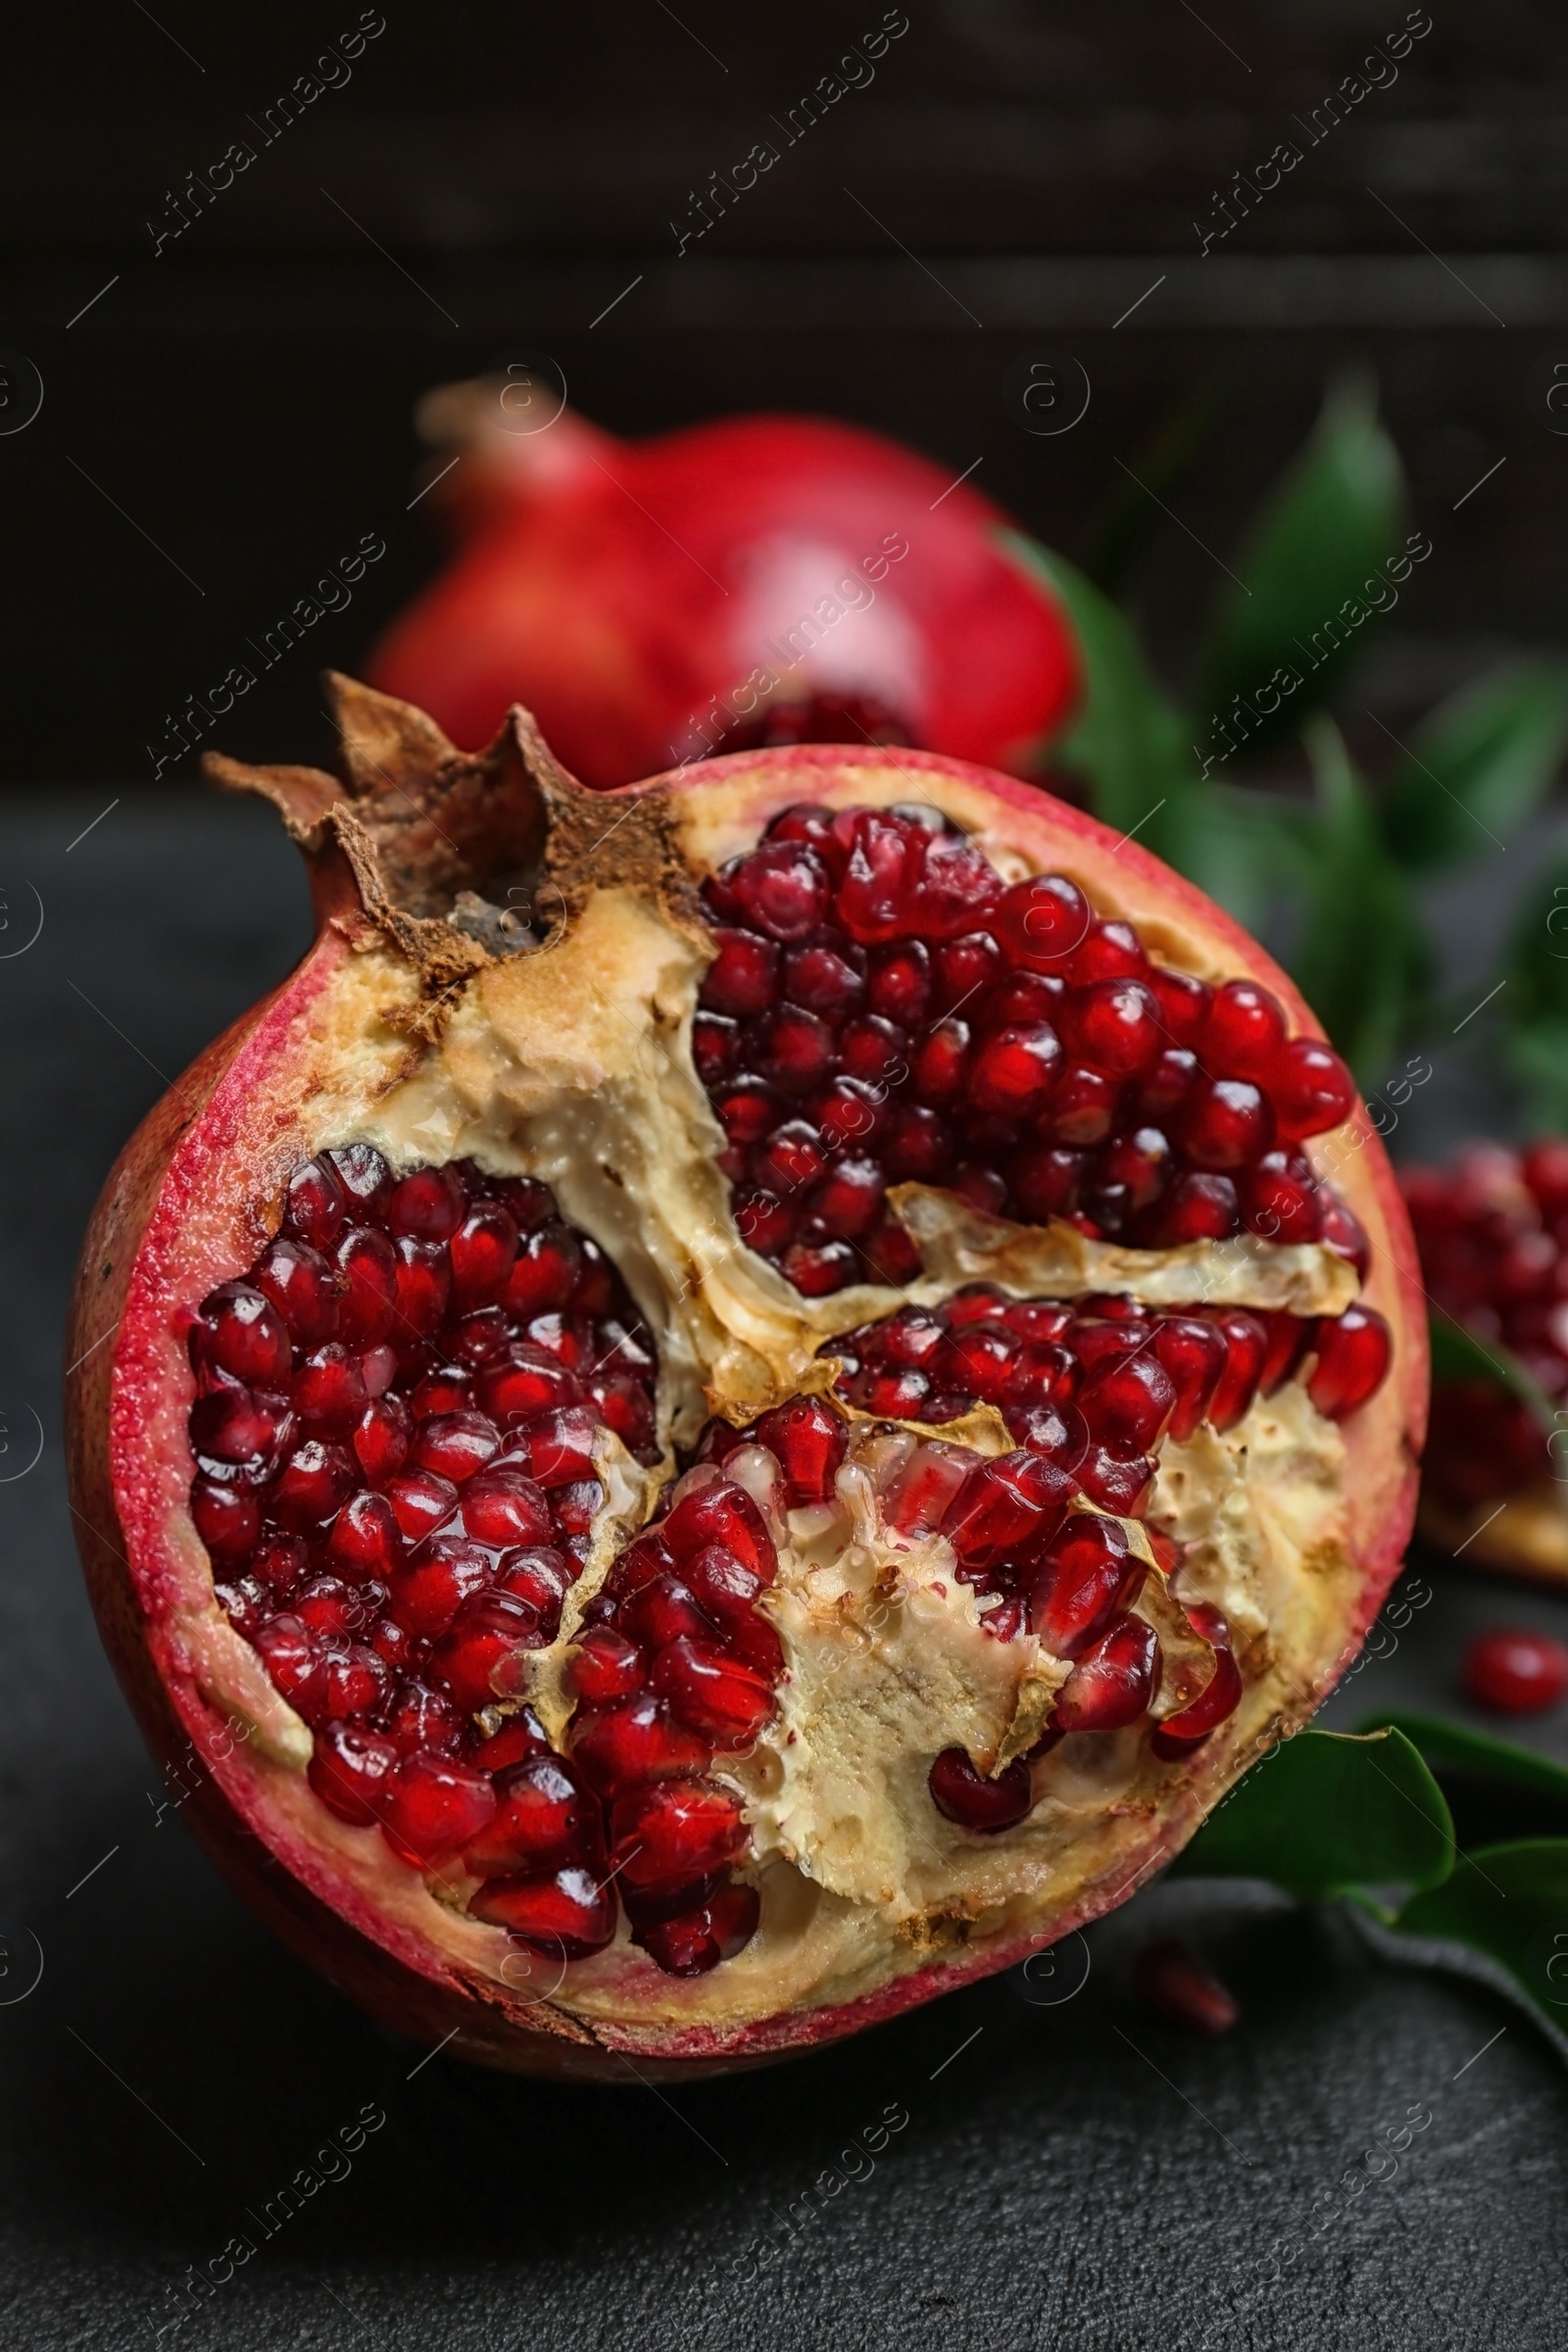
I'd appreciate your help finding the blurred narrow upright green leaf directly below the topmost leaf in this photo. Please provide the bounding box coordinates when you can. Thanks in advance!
[1291,719,1432,1092]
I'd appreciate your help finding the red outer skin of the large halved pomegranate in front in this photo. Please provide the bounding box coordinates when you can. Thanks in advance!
[66,680,1427,2082]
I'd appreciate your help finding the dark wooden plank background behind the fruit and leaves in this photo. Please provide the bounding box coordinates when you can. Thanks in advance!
[0,0,1568,786]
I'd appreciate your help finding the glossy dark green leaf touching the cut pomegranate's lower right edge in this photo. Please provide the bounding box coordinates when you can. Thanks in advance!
[1180,1731,1452,1903]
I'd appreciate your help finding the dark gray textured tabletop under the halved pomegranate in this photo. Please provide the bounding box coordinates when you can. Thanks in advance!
[0,786,1568,2352]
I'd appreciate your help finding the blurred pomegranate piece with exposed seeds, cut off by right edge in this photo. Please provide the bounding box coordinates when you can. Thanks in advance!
[1401,1136,1568,1583]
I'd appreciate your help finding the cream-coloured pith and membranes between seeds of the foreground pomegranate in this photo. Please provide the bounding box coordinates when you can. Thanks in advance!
[166,764,1361,2030]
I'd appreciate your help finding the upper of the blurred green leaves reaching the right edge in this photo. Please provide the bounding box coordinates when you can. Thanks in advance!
[1382,663,1568,872]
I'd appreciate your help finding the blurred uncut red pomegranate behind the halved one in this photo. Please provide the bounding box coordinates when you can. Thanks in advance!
[369,381,1079,786]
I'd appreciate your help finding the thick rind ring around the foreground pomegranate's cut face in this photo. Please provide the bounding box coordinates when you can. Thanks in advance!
[69,691,1425,2080]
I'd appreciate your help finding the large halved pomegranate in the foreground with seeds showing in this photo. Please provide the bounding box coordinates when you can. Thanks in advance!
[71,680,1425,2077]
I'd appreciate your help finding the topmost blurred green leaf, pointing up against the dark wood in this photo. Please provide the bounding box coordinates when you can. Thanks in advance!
[1199,383,1408,753]
